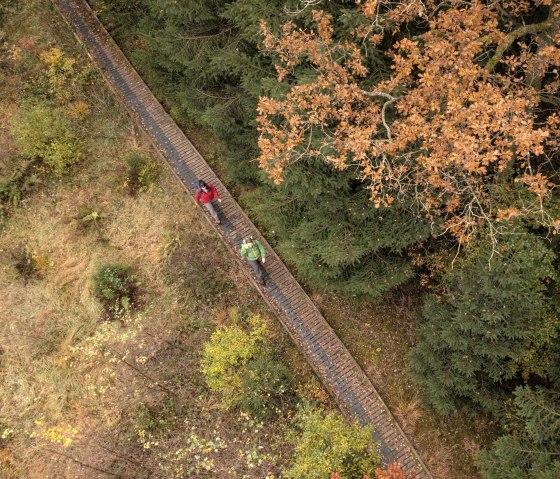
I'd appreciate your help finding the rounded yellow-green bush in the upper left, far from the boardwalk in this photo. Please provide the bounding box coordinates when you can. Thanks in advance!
[12,103,82,176]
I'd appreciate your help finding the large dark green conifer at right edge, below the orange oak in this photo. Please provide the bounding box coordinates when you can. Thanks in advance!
[410,232,560,416]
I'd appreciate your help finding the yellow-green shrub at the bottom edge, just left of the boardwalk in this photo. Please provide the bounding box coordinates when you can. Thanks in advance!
[284,404,379,479]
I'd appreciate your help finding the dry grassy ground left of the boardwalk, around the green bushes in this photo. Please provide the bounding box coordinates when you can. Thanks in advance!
[0,0,331,479]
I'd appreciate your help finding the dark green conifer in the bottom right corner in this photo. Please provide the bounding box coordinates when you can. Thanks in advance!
[477,383,560,479]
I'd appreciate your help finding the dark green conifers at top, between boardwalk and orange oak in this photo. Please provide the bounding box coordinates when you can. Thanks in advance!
[98,0,294,183]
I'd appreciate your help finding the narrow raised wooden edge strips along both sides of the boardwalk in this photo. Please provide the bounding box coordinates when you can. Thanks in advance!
[51,0,433,479]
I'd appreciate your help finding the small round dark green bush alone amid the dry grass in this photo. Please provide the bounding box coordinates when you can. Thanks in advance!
[93,263,137,315]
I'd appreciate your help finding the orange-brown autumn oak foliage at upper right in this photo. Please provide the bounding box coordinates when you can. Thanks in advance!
[257,0,560,241]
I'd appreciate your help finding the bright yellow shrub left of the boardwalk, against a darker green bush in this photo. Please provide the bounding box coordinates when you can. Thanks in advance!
[202,315,268,407]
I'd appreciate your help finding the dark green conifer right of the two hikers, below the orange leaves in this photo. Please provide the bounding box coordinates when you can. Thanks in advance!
[242,161,430,298]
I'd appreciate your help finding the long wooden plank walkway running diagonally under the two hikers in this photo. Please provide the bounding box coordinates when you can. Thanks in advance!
[52,0,433,479]
